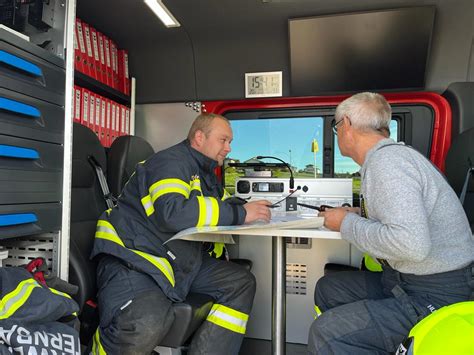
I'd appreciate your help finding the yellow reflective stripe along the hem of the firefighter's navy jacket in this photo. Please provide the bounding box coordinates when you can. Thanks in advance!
[95,219,175,287]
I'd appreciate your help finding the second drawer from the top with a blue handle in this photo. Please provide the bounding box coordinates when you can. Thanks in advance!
[0,88,64,144]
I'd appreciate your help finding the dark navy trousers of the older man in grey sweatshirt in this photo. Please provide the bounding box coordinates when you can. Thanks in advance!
[308,266,472,355]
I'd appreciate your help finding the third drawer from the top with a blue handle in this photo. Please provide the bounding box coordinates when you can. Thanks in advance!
[0,135,63,205]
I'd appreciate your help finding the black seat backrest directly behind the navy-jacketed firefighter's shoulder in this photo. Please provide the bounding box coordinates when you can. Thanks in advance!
[107,136,154,197]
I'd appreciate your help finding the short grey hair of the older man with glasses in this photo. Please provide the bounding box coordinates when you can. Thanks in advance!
[335,92,392,135]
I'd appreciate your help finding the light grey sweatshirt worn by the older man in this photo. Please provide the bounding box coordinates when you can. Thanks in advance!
[341,139,474,275]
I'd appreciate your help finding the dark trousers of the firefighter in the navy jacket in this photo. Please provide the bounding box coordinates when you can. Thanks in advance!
[94,254,256,355]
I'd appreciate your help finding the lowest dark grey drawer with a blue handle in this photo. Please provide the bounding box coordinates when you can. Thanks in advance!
[0,203,61,239]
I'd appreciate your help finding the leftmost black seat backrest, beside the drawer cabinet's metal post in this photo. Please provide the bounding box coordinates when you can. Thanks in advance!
[69,123,107,309]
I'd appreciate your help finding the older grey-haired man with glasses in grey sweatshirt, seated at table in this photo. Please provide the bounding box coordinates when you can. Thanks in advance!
[308,93,474,355]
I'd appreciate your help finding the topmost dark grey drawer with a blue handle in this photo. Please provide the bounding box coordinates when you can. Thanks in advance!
[0,39,66,106]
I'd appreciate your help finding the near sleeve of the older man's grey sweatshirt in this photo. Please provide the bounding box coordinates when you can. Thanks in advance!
[341,150,431,262]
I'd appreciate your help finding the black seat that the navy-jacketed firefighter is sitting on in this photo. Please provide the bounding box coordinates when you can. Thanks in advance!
[107,136,214,348]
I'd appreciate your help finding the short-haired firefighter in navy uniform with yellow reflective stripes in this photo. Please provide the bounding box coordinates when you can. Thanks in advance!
[92,114,271,354]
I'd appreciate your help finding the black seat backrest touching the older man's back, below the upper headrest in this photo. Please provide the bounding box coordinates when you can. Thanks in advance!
[446,128,474,230]
